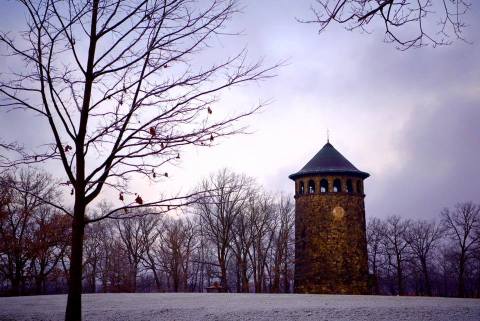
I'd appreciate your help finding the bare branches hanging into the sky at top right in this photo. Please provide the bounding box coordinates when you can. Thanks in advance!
[300,0,471,50]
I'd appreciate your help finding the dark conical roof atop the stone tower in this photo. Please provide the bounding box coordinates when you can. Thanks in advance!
[288,142,370,180]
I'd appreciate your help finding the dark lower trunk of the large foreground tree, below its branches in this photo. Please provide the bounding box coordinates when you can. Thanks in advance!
[65,204,85,321]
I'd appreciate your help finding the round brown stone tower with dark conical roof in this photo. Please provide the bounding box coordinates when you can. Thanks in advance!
[289,142,369,294]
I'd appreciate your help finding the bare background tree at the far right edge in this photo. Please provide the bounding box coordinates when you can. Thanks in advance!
[441,202,480,297]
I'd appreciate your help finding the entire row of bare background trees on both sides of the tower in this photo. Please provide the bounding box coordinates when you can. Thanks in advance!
[0,169,480,297]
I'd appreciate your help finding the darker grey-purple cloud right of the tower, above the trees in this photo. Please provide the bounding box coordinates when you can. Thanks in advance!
[368,98,480,218]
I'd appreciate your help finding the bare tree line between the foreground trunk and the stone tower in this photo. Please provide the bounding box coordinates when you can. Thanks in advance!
[79,170,294,292]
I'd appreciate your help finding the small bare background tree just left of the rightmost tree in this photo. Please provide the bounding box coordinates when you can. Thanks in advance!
[407,221,443,296]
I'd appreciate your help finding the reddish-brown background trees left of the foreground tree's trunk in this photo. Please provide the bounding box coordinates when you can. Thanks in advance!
[0,170,70,295]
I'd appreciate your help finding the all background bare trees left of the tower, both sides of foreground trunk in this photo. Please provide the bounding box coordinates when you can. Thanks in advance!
[0,170,294,295]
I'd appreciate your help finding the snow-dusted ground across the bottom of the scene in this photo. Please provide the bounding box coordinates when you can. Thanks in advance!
[0,293,480,321]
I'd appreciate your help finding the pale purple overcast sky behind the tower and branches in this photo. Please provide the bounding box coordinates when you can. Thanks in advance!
[0,0,480,218]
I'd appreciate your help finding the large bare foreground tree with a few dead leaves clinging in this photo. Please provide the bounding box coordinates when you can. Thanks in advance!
[0,0,274,320]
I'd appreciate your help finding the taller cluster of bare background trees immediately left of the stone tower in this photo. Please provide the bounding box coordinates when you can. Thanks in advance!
[194,170,294,293]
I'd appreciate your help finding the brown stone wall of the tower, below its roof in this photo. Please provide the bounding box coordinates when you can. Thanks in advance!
[295,176,368,294]
